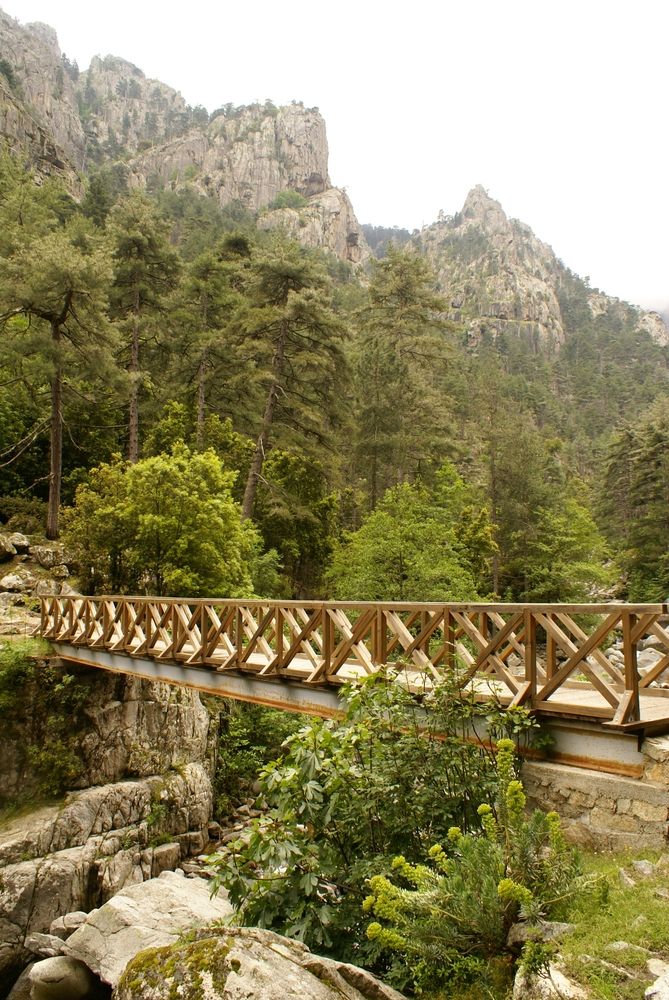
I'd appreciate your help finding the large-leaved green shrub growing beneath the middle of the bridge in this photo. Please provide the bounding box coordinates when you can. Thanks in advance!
[213,677,526,961]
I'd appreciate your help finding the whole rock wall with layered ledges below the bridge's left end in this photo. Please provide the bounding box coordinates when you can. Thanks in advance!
[0,592,220,996]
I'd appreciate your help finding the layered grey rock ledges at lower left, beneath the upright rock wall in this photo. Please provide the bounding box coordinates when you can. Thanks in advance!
[0,764,212,983]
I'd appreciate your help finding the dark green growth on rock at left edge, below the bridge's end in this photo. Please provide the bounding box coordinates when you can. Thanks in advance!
[0,640,88,803]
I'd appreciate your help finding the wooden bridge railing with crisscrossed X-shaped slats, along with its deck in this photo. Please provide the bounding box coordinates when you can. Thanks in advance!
[41,596,669,726]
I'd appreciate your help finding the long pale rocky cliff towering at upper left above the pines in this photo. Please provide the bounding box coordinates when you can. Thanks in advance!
[0,11,369,264]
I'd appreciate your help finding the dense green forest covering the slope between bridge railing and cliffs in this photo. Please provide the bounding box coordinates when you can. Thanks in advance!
[0,157,669,601]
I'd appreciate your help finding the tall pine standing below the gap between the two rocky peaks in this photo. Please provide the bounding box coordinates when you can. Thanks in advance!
[351,245,453,507]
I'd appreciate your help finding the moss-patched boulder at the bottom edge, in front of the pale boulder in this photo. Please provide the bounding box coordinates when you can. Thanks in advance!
[114,927,402,1000]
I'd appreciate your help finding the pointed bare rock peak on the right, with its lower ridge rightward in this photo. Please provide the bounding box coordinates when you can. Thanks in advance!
[414,185,669,353]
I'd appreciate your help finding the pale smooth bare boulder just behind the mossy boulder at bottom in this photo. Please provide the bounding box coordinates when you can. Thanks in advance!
[63,872,233,986]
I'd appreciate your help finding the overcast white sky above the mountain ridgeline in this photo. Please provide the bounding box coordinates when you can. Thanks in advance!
[5,0,669,308]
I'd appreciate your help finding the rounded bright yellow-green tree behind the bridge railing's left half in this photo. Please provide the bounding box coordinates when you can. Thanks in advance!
[66,443,258,597]
